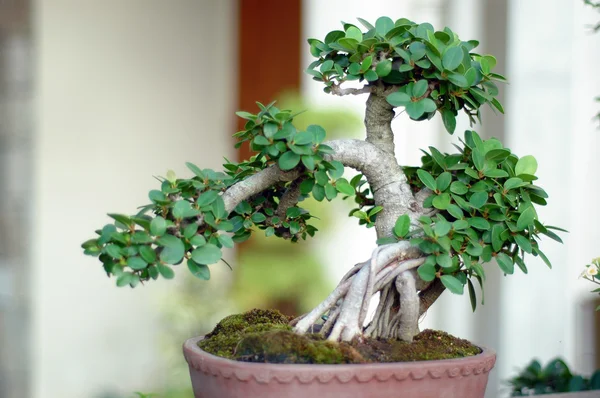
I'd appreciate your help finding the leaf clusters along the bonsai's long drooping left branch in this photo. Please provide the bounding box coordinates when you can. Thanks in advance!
[82,103,360,287]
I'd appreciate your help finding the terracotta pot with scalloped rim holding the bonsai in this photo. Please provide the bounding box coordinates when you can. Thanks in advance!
[183,337,496,398]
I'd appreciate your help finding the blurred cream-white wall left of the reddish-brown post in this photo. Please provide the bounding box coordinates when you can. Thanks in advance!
[31,0,235,398]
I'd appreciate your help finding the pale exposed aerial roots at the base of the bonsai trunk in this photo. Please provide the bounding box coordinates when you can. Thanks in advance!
[294,241,425,341]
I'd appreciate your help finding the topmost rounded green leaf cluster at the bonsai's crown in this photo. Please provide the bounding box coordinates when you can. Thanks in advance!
[307,17,505,134]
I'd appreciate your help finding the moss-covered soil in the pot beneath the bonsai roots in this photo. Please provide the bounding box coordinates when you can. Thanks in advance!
[198,310,481,364]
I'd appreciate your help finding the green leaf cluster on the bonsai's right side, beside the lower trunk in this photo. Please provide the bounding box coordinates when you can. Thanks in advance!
[379,131,564,310]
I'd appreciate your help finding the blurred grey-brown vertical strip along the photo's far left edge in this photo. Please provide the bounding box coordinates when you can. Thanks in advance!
[0,0,33,398]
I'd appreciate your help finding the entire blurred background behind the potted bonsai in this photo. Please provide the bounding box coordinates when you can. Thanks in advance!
[0,0,600,398]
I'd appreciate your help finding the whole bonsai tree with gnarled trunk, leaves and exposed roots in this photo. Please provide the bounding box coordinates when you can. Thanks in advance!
[83,17,560,341]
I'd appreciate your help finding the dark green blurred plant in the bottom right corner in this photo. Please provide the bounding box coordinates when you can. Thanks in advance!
[508,358,600,397]
